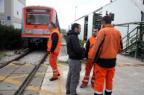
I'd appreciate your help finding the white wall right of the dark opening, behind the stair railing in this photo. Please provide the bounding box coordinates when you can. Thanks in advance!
[102,0,144,37]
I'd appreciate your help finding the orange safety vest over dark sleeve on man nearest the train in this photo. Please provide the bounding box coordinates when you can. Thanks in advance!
[47,29,61,53]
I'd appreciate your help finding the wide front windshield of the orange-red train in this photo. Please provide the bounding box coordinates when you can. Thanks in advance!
[27,13,49,25]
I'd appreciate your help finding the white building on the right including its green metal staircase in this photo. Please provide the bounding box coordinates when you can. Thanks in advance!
[75,0,144,59]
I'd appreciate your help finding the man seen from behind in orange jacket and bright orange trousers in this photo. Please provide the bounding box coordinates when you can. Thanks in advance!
[89,16,122,95]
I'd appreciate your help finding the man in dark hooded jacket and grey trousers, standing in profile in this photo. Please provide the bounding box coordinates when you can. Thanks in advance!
[66,23,84,95]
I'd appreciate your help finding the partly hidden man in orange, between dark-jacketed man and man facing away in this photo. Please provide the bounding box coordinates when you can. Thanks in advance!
[80,28,100,88]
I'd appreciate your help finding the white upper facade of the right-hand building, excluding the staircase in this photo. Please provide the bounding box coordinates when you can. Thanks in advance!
[75,0,144,40]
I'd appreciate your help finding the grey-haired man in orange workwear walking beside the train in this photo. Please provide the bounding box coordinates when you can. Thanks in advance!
[47,23,61,81]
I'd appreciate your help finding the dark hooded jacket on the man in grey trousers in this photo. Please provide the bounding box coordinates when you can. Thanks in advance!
[67,30,84,60]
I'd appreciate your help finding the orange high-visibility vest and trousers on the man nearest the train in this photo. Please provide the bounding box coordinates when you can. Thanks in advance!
[47,29,61,78]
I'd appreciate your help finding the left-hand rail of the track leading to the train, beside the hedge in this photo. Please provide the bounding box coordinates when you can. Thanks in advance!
[0,49,32,69]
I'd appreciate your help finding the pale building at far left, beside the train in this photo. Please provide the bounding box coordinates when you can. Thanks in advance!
[0,0,26,28]
